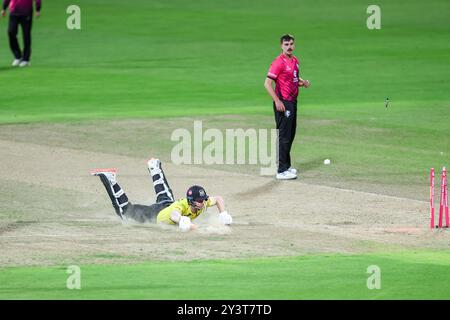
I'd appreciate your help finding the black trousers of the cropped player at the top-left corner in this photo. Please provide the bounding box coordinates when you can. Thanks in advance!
[8,14,33,61]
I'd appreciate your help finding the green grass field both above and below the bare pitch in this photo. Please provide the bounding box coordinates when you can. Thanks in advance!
[0,0,450,299]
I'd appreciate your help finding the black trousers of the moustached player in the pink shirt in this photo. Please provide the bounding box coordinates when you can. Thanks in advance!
[273,100,297,173]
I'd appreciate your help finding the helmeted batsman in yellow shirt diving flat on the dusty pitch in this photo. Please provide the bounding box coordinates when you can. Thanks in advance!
[91,158,233,231]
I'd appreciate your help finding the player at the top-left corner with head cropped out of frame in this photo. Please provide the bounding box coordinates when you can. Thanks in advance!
[2,0,41,67]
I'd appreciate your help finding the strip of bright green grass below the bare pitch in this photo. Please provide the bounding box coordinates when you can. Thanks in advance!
[0,251,450,300]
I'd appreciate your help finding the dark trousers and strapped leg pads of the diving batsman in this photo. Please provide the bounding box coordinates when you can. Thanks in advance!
[100,162,174,223]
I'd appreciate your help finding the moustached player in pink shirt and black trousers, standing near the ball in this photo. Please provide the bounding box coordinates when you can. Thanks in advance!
[264,34,309,180]
